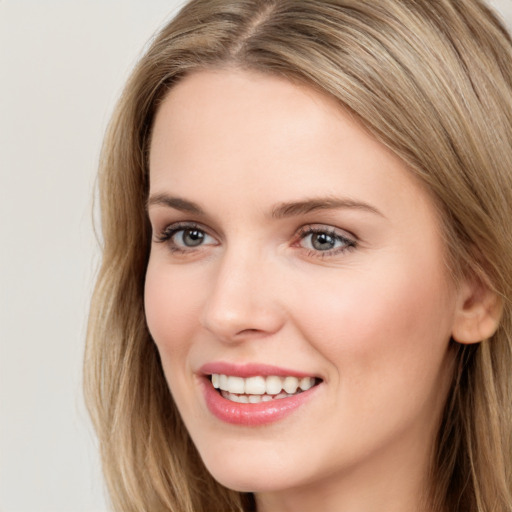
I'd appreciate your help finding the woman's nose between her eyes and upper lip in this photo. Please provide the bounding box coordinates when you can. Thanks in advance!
[201,250,285,342]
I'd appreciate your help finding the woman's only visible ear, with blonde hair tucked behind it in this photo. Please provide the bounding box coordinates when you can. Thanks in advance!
[452,276,502,344]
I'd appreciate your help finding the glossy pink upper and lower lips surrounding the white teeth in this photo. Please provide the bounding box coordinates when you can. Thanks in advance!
[200,362,319,426]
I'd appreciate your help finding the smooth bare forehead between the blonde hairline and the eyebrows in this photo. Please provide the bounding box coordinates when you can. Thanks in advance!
[150,70,436,228]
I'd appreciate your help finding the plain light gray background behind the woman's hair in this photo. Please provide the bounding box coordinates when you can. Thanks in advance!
[0,0,512,512]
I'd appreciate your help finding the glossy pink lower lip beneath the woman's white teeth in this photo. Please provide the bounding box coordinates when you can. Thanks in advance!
[202,378,319,426]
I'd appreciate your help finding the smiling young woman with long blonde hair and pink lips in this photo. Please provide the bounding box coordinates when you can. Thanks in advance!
[85,0,512,512]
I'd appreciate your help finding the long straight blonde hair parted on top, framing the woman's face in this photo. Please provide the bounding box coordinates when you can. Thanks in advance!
[85,0,512,512]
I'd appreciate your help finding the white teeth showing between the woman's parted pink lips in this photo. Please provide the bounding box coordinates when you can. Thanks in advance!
[209,373,321,404]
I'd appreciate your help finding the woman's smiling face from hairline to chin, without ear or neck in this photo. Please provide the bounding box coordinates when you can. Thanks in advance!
[145,70,457,510]
